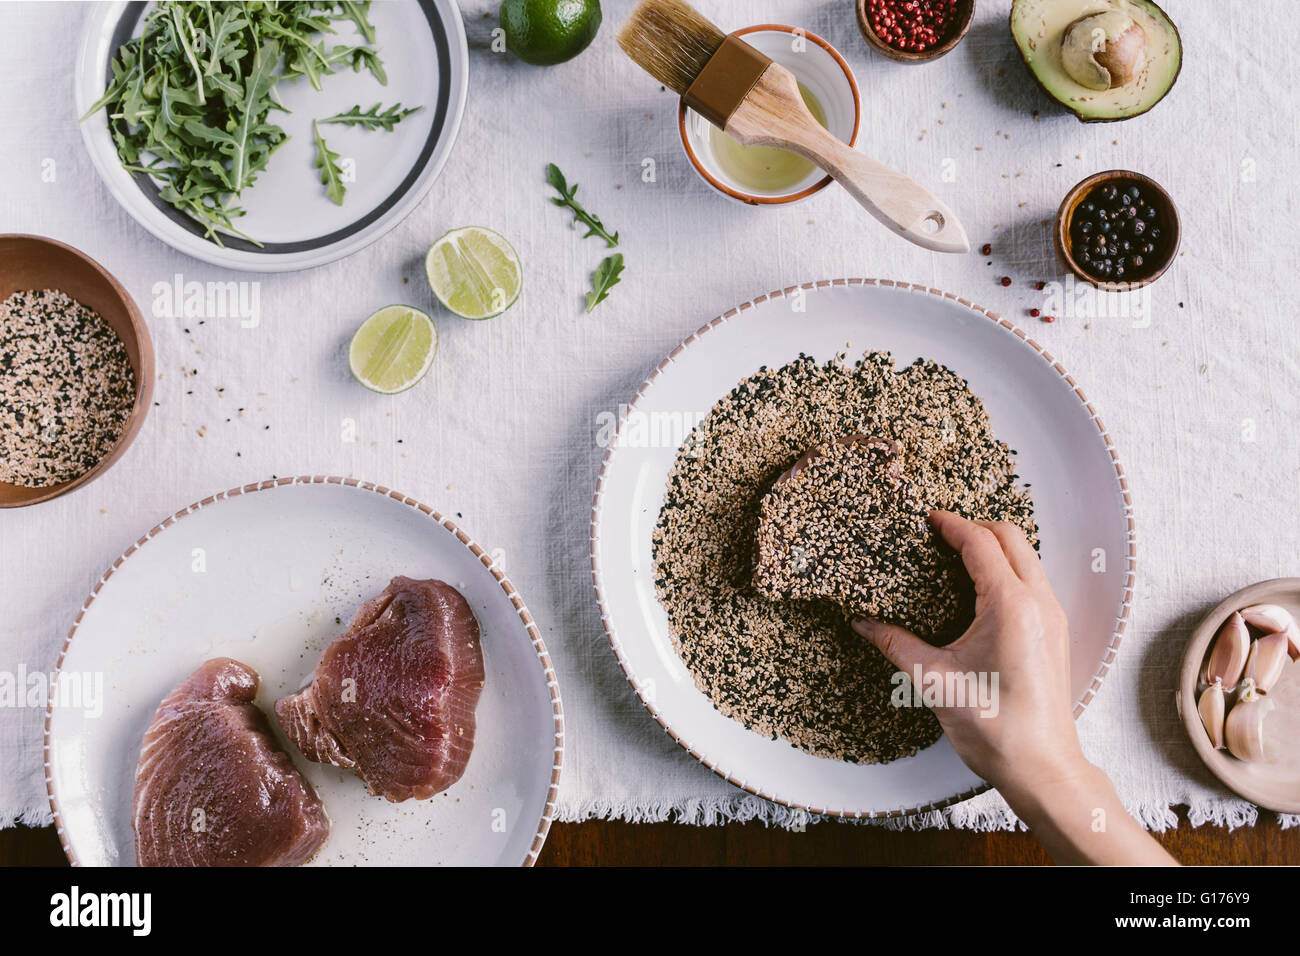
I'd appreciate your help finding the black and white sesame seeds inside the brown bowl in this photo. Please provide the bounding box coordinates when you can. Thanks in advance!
[0,289,135,488]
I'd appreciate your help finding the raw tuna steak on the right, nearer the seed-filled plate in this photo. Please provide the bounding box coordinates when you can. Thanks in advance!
[276,578,484,801]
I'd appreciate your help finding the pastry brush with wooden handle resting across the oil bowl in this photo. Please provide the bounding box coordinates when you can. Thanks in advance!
[618,0,970,252]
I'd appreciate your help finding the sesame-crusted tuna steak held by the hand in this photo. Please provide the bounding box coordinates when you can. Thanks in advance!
[754,433,975,644]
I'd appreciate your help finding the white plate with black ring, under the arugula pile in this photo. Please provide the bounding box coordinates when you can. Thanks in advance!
[74,0,469,272]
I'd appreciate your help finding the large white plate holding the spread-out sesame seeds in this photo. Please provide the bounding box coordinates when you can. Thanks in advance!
[592,278,1136,817]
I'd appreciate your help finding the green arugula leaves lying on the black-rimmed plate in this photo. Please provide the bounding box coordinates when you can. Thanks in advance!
[82,0,406,245]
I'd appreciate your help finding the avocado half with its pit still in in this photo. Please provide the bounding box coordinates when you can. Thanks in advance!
[1011,0,1183,122]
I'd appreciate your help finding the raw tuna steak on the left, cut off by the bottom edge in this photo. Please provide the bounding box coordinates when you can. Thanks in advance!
[134,657,329,866]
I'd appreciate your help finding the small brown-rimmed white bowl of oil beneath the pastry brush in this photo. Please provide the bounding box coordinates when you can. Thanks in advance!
[677,23,862,206]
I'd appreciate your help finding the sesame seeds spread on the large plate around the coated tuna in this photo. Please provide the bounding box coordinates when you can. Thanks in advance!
[654,352,1037,763]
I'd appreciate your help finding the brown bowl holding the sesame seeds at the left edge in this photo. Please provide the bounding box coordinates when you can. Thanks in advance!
[0,235,155,507]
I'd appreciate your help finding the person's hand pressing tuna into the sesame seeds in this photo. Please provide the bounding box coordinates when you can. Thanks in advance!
[853,511,1175,865]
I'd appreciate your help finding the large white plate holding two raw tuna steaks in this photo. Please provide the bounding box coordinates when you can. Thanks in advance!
[46,477,563,866]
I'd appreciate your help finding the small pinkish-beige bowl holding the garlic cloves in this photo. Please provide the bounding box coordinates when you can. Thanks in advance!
[1174,578,1300,813]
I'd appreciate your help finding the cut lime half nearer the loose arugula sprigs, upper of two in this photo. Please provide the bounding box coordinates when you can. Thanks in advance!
[424,226,524,319]
